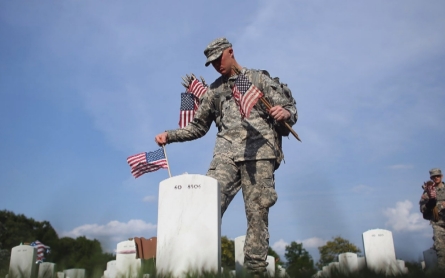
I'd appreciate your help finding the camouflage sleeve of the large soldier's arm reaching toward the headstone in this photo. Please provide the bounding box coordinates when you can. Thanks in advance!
[167,90,215,143]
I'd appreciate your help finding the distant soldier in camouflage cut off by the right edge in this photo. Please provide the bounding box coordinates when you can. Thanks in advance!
[419,168,445,271]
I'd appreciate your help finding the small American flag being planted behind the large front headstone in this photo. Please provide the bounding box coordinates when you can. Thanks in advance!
[127,148,168,178]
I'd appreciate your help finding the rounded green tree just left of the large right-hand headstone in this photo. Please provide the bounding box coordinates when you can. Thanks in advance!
[317,236,361,269]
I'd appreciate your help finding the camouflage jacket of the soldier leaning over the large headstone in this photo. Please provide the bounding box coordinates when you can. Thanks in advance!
[167,68,297,161]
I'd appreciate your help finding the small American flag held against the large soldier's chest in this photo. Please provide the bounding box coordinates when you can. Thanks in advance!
[232,74,264,118]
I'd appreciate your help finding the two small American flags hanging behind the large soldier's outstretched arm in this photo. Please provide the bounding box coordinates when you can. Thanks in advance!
[179,78,207,128]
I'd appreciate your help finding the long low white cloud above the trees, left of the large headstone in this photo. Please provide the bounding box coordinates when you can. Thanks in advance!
[61,219,156,252]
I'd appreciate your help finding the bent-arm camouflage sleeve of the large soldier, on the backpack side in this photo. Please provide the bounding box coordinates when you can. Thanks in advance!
[255,73,298,126]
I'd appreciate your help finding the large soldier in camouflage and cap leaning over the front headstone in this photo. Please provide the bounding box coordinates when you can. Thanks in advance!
[155,38,297,274]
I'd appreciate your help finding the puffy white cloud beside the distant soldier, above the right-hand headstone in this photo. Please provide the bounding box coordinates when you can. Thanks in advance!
[383,200,428,232]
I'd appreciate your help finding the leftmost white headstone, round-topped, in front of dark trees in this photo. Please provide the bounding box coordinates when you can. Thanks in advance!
[8,245,37,278]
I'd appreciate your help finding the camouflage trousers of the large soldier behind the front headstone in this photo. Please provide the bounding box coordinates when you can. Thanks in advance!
[207,155,277,273]
